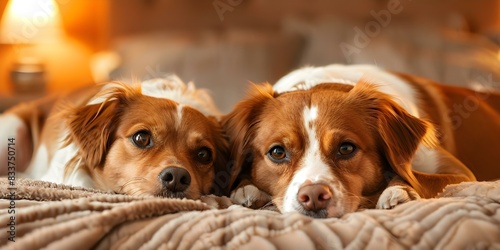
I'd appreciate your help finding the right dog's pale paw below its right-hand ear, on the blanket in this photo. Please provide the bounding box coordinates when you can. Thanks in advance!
[376,185,420,209]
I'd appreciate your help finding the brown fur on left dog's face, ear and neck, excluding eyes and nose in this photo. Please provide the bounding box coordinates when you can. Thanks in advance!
[1,83,228,199]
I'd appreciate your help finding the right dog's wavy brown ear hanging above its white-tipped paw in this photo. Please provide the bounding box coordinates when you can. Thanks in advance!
[354,82,437,195]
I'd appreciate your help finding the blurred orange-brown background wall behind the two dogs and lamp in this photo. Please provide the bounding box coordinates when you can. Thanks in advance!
[0,0,500,111]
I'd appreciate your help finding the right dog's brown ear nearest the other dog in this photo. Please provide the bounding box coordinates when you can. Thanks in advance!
[222,83,276,194]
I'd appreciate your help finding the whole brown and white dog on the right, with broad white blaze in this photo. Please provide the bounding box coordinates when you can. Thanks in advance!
[223,65,500,218]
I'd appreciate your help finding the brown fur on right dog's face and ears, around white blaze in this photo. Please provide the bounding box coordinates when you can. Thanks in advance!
[223,78,482,215]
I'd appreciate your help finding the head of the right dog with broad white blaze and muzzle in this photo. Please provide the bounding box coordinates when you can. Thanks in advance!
[223,82,435,217]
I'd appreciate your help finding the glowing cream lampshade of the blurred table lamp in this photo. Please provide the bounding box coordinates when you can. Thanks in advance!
[0,0,63,44]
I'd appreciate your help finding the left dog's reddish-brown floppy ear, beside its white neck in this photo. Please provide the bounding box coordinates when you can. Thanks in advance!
[65,84,140,176]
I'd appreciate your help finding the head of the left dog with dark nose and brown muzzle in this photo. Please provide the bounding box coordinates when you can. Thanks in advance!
[66,77,227,199]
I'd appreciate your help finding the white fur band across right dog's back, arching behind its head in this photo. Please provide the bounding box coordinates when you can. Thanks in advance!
[273,64,419,117]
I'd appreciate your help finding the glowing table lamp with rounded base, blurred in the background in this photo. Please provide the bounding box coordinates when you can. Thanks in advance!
[0,0,64,93]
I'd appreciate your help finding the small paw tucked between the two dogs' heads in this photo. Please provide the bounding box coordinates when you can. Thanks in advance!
[231,185,272,209]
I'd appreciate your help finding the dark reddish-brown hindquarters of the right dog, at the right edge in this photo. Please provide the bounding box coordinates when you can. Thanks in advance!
[398,74,500,181]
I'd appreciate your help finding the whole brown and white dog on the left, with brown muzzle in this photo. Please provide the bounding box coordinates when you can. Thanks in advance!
[0,76,228,199]
